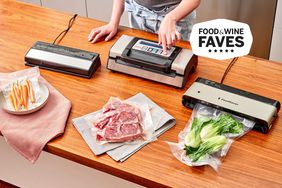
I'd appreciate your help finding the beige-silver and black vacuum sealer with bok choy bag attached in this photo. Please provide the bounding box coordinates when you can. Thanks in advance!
[182,78,280,133]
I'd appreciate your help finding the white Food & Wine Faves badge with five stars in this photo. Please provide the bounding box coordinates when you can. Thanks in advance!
[190,19,253,60]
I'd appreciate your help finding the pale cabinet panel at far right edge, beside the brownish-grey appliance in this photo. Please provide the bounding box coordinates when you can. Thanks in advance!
[269,0,282,63]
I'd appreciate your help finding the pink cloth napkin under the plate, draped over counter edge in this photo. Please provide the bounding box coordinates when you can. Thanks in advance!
[0,67,71,163]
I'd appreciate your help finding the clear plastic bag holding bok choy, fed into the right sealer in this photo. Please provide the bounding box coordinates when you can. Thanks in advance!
[168,104,255,171]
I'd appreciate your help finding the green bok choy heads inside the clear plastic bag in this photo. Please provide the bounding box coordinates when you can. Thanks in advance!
[184,113,244,162]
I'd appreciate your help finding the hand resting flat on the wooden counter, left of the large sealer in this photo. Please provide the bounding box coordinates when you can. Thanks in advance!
[88,23,118,43]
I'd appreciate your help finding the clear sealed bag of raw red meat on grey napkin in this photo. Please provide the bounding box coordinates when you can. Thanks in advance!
[87,97,154,144]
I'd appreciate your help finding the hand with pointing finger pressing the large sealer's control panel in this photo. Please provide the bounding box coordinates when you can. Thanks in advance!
[159,14,181,54]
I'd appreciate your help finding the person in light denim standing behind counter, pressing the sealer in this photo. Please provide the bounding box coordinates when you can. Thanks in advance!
[88,0,200,54]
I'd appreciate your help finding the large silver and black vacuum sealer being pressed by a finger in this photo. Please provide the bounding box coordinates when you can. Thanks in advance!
[107,35,198,88]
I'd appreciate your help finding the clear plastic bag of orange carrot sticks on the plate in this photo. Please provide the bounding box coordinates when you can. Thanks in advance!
[1,71,41,111]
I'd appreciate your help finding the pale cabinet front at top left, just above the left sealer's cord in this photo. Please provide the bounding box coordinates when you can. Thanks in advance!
[41,0,87,17]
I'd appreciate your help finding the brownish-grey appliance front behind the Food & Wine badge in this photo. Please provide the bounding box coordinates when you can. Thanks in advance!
[197,0,277,59]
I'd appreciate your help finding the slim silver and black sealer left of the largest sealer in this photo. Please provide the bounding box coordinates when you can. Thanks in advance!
[25,41,101,78]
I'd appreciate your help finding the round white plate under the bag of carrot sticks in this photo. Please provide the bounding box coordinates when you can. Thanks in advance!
[0,82,49,115]
